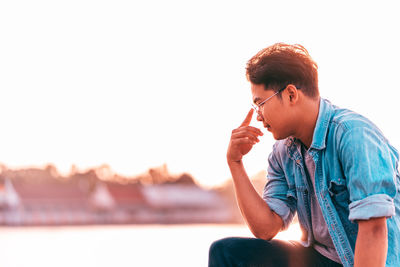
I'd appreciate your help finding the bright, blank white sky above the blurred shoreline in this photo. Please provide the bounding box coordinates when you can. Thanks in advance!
[0,0,400,188]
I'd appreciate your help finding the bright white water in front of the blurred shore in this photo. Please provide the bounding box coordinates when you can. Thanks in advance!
[0,225,300,267]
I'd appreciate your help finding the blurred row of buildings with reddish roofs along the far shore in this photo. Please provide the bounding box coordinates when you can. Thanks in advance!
[0,166,235,225]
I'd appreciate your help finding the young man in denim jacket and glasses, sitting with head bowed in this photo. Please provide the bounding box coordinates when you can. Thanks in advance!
[209,43,400,267]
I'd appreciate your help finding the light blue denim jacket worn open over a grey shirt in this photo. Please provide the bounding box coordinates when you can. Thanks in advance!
[263,99,400,267]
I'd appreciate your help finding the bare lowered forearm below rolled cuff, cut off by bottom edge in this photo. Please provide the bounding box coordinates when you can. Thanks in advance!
[354,218,388,267]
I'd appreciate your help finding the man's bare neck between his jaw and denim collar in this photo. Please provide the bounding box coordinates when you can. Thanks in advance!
[294,97,320,149]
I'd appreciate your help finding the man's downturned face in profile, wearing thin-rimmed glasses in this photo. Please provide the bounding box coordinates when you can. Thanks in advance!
[251,83,291,140]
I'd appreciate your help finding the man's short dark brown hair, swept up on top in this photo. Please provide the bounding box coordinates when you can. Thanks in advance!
[246,43,319,98]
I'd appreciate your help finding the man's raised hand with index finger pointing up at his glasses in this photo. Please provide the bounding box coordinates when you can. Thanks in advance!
[227,109,263,162]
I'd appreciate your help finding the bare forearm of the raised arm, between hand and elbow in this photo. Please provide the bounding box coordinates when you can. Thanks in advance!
[228,161,283,240]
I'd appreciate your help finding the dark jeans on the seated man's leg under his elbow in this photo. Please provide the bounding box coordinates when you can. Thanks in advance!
[208,237,342,267]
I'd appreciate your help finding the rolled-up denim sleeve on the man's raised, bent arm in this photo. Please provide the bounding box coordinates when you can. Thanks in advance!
[263,146,295,230]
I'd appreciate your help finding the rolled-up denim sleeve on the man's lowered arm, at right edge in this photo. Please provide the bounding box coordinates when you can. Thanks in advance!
[339,127,398,221]
